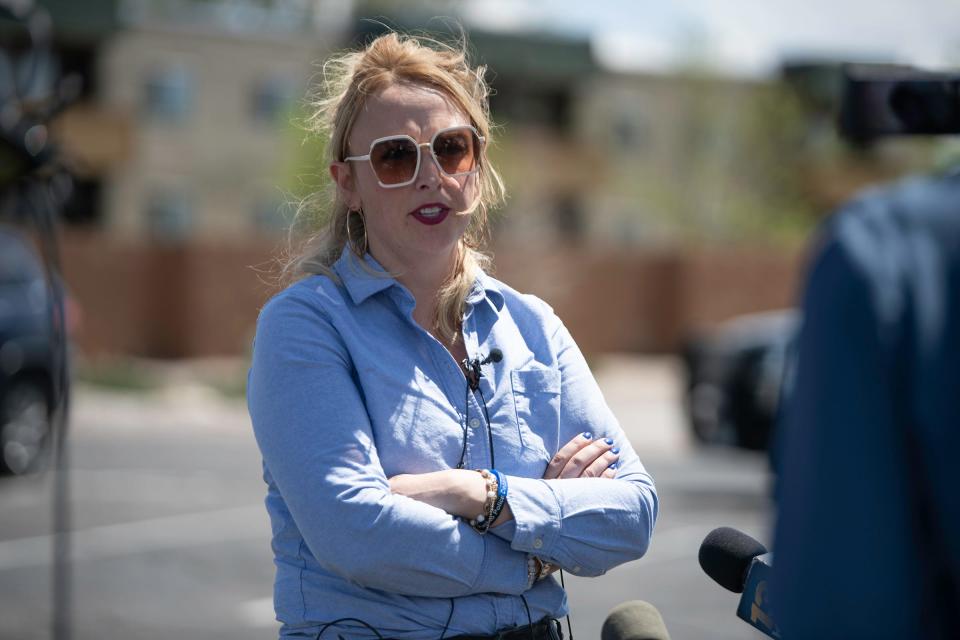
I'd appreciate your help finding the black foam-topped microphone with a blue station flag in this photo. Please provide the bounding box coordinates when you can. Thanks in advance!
[699,527,781,638]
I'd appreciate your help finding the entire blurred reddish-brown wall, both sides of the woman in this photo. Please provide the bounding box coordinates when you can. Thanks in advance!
[62,233,801,358]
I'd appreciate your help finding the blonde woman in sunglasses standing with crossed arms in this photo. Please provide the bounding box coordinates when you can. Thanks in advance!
[248,34,657,640]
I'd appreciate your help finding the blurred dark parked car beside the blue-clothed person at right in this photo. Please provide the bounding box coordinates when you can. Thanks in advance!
[683,310,800,450]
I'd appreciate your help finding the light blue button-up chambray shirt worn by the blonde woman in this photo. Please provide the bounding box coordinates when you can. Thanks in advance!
[247,251,657,640]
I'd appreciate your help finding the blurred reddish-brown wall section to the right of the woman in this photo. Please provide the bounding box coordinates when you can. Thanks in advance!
[496,248,803,352]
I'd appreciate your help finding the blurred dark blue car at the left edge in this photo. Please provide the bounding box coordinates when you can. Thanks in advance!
[0,227,55,474]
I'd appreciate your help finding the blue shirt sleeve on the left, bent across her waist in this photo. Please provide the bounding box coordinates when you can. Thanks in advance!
[247,289,527,597]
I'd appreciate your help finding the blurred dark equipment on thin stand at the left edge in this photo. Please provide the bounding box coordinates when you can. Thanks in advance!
[0,0,80,640]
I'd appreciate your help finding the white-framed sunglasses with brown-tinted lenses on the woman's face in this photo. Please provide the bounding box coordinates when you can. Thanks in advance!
[343,124,485,189]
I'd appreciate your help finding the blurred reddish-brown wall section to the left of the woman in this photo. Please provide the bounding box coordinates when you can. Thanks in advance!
[62,234,273,358]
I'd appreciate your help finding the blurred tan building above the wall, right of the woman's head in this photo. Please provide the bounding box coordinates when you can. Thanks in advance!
[354,22,812,250]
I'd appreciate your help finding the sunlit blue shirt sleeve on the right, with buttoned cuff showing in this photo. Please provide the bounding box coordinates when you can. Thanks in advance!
[491,316,658,576]
